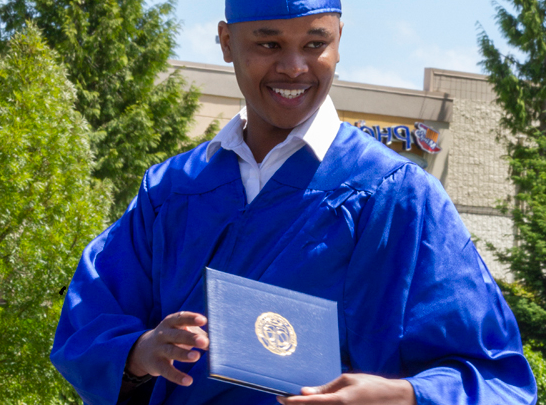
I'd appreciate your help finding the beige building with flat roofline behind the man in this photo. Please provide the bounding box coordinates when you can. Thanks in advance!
[160,60,514,278]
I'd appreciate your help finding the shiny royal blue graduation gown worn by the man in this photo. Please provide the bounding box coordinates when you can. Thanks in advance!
[51,124,536,405]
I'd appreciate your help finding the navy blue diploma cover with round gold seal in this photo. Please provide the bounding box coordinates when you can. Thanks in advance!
[205,268,341,395]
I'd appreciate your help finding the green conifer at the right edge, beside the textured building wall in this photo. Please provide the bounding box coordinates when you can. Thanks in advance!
[478,0,546,398]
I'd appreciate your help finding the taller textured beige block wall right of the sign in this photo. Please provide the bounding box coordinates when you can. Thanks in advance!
[425,71,514,280]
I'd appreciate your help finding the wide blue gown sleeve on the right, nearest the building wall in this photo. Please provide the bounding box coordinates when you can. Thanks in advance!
[344,165,536,405]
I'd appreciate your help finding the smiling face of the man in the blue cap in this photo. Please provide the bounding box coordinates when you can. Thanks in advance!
[218,14,342,130]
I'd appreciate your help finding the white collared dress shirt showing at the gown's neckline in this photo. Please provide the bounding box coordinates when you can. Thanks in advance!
[207,96,341,204]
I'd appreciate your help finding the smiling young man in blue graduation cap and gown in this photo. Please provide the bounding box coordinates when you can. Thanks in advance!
[51,0,536,405]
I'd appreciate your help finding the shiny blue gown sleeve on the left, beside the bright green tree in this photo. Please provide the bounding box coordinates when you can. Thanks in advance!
[51,169,155,405]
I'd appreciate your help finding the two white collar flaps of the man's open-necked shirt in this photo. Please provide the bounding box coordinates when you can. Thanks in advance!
[206,96,341,162]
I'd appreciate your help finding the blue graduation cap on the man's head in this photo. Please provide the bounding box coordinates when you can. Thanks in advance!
[226,0,341,24]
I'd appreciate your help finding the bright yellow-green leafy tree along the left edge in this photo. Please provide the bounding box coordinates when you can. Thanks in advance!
[0,25,111,405]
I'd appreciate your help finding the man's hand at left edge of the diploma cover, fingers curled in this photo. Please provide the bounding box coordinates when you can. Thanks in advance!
[126,312,209,386]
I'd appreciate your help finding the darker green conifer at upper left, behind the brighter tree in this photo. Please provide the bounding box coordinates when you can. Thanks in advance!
[0,0,208,219]
